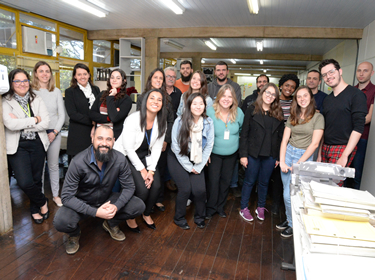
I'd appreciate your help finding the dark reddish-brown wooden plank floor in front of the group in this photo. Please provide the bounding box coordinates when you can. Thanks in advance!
[0,176,295,280]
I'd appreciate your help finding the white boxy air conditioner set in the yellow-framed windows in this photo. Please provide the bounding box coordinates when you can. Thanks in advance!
[22,26,53,56]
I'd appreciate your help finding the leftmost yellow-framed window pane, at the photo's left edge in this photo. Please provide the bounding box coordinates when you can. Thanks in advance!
[0,9,17,49]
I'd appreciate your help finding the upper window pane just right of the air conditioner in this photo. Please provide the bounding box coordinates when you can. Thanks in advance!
[60,27,83,60]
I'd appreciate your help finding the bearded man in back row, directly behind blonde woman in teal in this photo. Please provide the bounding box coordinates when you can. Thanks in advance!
[207,61,242,105]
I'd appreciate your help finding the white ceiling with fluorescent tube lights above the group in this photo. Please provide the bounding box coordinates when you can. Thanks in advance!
[0,0,375,76]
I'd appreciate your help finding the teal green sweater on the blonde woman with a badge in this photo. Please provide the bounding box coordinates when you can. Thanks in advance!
[207,107,244,156]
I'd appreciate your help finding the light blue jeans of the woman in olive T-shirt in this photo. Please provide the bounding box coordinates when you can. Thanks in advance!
[280,144,314,227]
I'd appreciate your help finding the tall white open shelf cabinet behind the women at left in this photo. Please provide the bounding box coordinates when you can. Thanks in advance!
[120,37,145,93]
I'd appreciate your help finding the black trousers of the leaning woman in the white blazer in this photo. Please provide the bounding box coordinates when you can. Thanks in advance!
[128,158,161,216]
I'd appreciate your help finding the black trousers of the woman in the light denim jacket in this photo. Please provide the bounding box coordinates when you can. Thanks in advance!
[168,150,206,225]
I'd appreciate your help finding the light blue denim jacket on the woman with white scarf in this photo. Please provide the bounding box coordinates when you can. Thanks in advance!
[171,117,215,173]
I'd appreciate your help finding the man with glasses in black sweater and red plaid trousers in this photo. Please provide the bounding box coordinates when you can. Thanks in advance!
[318,59,367,178]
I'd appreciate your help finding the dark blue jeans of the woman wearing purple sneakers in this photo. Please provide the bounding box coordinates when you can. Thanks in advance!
[241,156,276,209]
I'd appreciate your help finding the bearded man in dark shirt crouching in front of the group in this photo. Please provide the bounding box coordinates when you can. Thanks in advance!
[53,125,145,255]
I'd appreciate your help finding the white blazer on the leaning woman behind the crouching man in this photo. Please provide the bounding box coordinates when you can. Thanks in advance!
[113,111,165,171]
